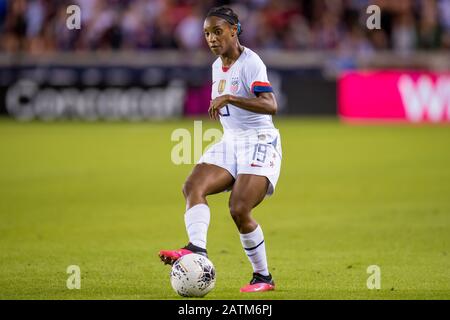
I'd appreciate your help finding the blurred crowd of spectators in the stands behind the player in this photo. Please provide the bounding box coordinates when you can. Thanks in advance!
[0,0,450,53]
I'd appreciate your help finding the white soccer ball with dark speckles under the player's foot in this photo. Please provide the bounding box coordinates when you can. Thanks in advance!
[170,253,216,297]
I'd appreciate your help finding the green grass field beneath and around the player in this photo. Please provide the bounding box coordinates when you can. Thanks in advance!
[0,118,450,299]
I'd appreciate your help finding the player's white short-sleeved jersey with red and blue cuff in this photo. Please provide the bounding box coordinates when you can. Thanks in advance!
[211,48,274,131]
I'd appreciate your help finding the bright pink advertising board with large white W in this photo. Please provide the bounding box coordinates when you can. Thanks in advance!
[338,71,450,122]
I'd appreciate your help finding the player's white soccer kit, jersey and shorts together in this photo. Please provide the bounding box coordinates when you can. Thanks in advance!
[199,48,282,195]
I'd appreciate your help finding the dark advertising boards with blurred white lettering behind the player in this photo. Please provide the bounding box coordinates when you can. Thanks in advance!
[0,64,337,120]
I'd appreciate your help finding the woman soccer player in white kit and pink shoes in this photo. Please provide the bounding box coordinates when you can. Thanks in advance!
[159,7,282,292]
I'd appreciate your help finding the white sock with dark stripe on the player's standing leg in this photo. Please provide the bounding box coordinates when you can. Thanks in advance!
[240,225,269,276]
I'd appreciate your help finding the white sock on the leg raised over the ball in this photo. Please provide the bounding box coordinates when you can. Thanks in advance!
[184,204,210,249]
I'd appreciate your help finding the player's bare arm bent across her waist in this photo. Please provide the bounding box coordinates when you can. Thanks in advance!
[208,92,278,119]
